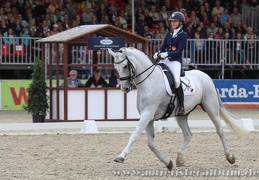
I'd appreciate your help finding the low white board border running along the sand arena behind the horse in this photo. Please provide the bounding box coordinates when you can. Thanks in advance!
[0,118,259,134]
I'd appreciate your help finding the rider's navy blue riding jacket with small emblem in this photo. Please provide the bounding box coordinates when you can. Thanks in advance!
[159,29,187,63]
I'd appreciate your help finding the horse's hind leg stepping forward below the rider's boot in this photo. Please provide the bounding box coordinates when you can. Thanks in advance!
[176,115,192,167]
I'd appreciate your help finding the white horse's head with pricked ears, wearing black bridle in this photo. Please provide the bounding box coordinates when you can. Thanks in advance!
[108,48,135,93]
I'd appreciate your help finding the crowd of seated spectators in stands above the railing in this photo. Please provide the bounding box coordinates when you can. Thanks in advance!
[0,0,258,39]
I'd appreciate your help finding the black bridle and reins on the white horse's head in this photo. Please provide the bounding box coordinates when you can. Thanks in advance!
[114,53,157,86]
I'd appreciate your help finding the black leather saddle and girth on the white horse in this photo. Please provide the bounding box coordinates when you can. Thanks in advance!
[158,63,185,119]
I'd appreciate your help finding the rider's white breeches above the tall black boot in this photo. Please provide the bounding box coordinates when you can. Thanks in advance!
[160,58,181,88]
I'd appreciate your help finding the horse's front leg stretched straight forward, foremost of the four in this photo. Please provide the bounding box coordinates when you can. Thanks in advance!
[114,112,153,163]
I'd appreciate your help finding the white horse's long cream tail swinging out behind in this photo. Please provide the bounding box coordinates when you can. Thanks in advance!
[218,94,248,136]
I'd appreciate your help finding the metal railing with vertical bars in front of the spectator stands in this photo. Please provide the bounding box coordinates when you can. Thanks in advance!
[0,37,259,75]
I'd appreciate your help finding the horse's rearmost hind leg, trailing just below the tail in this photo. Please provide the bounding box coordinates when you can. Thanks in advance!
[204,107,235,164]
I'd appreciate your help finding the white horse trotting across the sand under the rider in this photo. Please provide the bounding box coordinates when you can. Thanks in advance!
[108,47,247,170]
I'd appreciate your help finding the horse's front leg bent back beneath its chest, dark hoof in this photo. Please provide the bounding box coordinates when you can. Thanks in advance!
[145,121,173,171]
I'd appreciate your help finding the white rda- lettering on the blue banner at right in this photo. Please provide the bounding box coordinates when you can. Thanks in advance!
[217,84,259,98]
